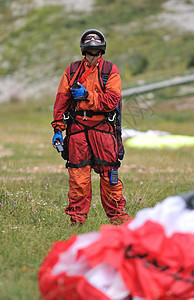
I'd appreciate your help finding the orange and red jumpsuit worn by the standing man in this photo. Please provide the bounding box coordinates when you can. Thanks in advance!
[52,57,130,223]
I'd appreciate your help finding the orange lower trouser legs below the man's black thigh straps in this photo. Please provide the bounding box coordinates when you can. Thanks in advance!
[65,165,130,224]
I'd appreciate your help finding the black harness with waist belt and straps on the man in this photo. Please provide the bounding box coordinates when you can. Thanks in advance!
[63,60,124,167]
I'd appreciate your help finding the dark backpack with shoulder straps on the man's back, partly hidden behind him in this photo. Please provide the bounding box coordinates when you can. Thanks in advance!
[70,60,125,160]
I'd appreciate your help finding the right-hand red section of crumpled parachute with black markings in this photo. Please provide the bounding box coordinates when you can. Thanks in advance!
[79,221,194,300]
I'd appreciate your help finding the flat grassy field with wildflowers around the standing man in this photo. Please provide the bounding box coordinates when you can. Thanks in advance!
[0,86,194,300]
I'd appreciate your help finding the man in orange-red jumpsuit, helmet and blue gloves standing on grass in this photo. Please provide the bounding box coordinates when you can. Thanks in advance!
[51,29,130,224]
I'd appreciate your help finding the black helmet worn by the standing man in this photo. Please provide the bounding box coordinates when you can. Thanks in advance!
[80,29,106,55]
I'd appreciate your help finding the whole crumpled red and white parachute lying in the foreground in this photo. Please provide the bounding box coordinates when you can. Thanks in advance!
[39,196,194,300]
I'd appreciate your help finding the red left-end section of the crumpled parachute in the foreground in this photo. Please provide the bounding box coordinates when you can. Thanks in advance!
[38,236,110,300]
